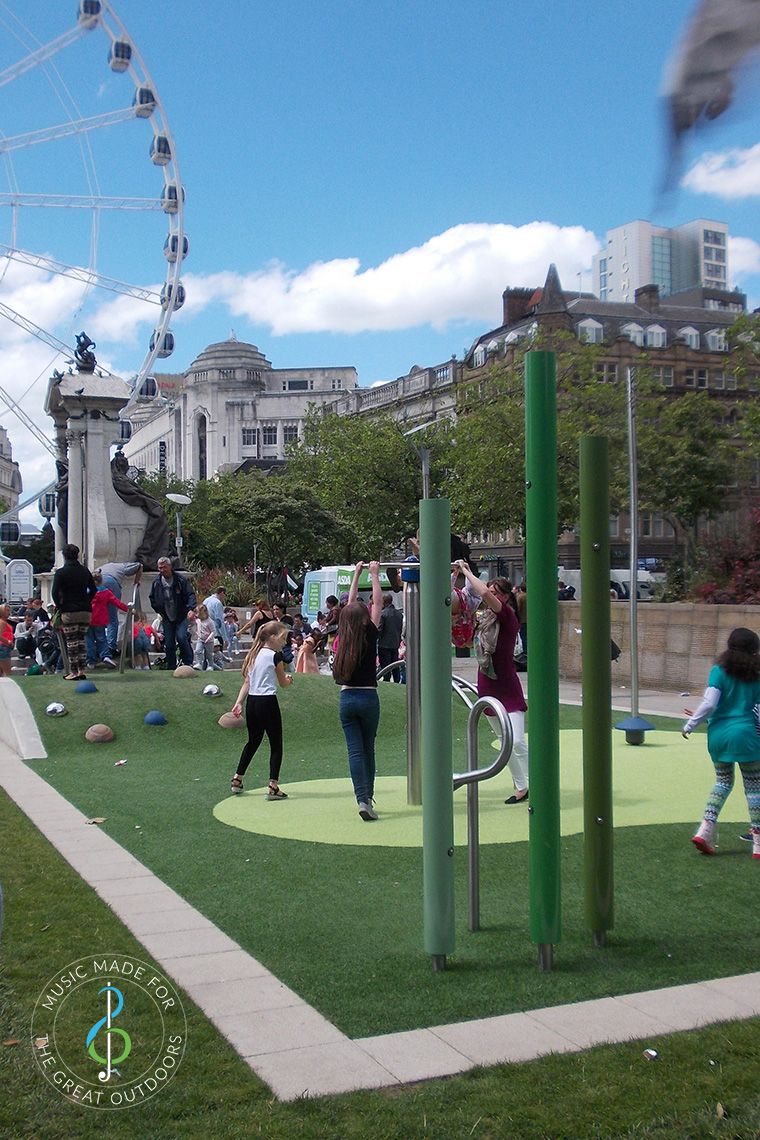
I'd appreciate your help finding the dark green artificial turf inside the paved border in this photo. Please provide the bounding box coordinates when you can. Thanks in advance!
[10,674,759,1036]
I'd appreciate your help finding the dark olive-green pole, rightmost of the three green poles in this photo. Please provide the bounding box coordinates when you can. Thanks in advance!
[580,435,615,946]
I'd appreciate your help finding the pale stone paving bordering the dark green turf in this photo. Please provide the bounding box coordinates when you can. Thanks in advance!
[0,662,760,1100]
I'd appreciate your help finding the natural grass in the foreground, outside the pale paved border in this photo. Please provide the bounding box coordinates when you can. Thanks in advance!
[0,793,760,1140]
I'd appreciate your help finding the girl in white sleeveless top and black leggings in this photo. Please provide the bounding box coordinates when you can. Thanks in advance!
[230,621,293,799]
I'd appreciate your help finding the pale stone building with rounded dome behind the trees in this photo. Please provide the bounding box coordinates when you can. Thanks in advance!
[124,335,358,480]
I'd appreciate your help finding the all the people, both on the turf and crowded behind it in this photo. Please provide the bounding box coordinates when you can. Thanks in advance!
[5,544,760,860]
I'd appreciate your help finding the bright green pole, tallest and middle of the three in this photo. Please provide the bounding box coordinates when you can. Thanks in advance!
[525,352,561,969]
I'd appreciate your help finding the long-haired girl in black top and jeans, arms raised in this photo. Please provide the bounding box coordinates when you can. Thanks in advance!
[333,562,383,823]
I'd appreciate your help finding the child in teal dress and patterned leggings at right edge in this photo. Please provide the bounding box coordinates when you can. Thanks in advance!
[683,628,760,860]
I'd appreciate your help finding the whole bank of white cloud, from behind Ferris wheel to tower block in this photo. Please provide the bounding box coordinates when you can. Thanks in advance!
[0,221,599,518]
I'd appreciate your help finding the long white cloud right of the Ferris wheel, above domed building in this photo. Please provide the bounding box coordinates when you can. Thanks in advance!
[180,221,599,336]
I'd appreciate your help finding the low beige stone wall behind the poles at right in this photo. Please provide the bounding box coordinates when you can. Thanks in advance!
[559,602,760,690]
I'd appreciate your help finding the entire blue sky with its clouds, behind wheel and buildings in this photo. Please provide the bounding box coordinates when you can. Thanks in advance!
[0,0,760,524]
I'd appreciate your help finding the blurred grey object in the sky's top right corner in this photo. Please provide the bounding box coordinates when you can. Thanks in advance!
[664,0,760,189]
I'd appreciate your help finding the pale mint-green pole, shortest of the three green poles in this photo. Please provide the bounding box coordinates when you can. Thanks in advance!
[419,498,455,970]
